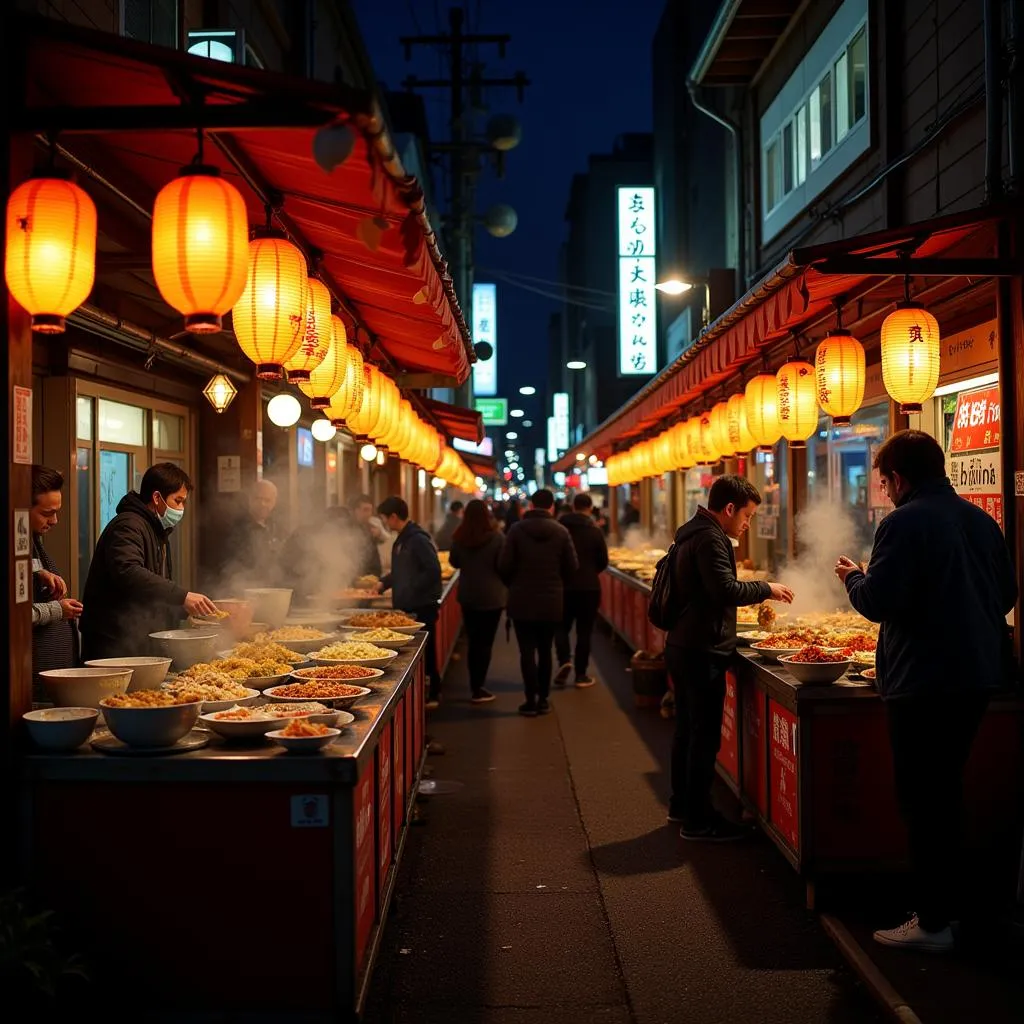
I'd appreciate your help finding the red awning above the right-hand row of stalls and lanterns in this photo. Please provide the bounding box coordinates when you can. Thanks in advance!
[554,211,995,471]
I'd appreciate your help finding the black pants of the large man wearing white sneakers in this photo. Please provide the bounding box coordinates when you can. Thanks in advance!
[886,694,988,932]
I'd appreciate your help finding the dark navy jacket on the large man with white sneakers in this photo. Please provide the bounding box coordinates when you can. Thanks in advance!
[846,480,1017,699]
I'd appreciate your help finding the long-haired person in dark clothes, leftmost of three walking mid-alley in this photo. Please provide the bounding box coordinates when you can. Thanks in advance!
[449,501,508,703]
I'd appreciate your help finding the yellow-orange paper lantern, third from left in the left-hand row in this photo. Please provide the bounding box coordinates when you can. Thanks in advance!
[231,234,309,380]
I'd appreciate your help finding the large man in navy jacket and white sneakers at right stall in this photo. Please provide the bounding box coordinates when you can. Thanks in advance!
[836,430,1017,952]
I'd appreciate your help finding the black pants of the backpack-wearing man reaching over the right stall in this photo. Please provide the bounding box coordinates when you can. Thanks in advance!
[665,647,729,828]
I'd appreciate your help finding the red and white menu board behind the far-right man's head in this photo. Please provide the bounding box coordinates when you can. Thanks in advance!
[946,384,1002,528]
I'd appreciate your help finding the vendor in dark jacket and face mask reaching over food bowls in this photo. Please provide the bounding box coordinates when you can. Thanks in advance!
[81,462,216,659]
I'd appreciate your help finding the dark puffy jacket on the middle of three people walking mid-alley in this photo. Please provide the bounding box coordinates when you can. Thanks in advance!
[498,509,580,623]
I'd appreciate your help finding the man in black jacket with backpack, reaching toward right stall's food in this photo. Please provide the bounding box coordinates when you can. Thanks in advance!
[665,475,793,843]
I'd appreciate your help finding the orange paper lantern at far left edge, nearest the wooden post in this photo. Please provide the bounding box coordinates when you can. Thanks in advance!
[4,177,96,334]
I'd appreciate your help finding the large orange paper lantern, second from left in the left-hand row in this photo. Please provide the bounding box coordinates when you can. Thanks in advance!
[152,164,249,334]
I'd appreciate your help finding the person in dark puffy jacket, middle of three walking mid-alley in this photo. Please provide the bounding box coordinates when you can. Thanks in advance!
[498,489,579,718]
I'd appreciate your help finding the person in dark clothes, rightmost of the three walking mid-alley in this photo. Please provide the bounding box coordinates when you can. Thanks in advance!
[555,495,608,689]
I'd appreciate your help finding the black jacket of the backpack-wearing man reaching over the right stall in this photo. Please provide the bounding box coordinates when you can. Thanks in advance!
[666,508,771,654]
